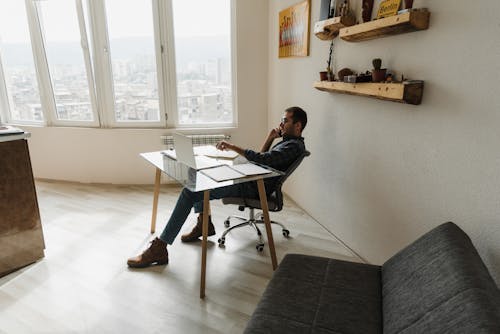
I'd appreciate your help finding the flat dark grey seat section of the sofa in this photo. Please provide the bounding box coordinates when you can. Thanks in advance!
[245,254,382,334]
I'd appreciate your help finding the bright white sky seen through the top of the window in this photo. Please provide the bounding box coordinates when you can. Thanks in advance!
[0,0,231,43]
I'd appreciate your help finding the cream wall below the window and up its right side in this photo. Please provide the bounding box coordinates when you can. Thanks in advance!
[23,0,268,184]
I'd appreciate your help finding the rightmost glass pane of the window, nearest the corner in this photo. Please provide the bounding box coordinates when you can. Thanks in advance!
[173,0,233,124]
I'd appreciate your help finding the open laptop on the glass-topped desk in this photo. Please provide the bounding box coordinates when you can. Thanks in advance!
[164,133,224,170]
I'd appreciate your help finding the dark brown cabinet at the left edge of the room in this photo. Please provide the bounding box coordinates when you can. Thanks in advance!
[0,135,45,276]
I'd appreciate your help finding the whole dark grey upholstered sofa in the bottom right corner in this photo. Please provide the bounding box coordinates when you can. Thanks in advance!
[245,223,500,334]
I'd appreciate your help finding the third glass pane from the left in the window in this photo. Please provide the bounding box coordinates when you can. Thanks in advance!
[106,0,160,122]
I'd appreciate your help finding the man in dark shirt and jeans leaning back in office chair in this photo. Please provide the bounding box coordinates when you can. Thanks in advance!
[127,107,307,268]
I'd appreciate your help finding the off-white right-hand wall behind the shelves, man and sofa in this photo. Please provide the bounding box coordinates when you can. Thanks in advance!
[269,0,500,284]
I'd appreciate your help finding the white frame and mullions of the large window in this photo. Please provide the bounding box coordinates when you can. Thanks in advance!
[0,0,238,129]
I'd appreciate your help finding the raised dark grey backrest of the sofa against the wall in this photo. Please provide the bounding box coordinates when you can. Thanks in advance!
[382,223,500,333]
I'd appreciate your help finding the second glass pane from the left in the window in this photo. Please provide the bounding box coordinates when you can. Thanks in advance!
[38,0,94,121]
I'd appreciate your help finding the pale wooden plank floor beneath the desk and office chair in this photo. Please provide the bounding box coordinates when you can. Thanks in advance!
[0,181,361,334]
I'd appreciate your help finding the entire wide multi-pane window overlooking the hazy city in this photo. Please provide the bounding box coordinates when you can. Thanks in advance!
[0,0,236,127]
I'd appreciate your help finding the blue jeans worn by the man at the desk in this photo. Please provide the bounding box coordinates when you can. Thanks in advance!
[160,182,259,245]
